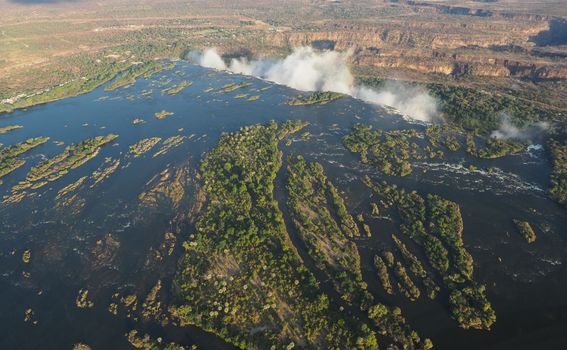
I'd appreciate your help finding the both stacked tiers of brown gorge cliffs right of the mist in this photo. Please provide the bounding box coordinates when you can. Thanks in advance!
[254,16,567,79]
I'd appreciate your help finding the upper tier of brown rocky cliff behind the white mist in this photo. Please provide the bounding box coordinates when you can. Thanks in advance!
[266,18,549,49]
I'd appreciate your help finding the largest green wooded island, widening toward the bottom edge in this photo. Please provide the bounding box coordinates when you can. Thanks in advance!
[172,122,377,348]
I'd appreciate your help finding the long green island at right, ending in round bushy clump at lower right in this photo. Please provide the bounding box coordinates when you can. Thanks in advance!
[364,177,496,329]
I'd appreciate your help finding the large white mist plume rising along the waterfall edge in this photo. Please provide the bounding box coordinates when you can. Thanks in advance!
[189,47,439,121]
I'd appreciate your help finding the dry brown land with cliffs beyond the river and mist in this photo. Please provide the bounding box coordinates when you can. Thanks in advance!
[0,0,567,110]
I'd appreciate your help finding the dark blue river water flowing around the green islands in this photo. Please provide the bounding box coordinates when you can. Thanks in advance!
[0,62,567,349]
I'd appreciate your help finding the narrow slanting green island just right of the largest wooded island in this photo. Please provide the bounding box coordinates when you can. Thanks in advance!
[286,156,373,309]
